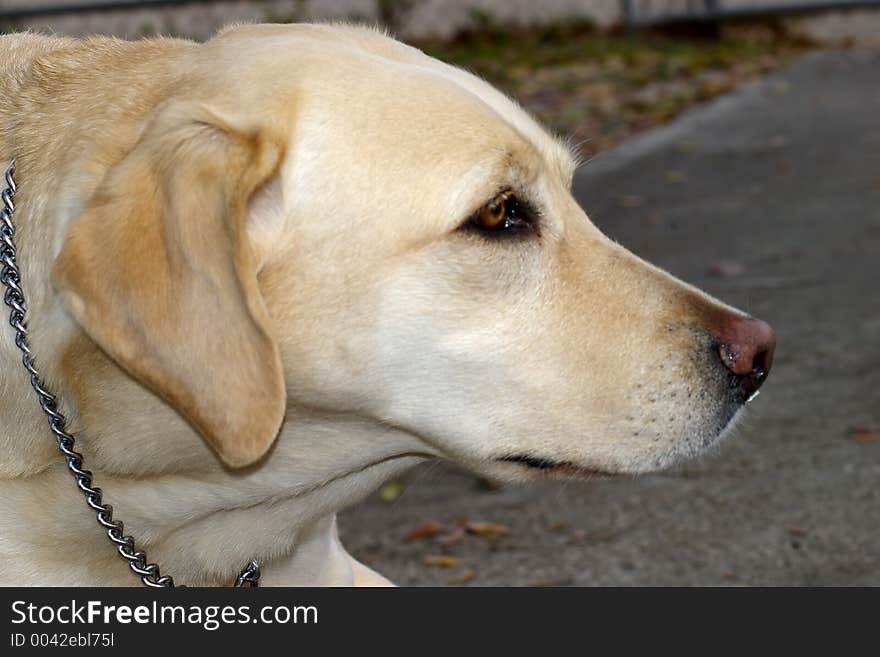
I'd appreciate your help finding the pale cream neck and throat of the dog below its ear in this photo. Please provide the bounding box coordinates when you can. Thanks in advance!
[0,164,429,586]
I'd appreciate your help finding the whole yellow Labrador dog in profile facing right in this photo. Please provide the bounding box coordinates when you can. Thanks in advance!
[0,25,775,586]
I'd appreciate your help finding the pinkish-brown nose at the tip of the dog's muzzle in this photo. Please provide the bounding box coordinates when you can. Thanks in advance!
[717,317,776,398]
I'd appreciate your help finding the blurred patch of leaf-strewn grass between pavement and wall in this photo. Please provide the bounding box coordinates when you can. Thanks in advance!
[415,23,809,157]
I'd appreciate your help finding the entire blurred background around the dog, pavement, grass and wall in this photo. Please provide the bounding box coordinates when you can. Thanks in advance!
[8,0,880,586]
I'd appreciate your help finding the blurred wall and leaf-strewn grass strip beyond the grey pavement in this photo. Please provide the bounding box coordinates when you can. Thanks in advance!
[0,0,880,156]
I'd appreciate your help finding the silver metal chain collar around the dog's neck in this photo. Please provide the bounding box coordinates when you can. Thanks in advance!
[0,160,260,589]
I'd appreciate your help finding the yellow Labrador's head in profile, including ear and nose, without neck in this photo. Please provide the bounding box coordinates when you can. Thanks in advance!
[55,26,774,478]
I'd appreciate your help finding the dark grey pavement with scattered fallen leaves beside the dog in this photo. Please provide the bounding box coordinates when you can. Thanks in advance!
[340,51,880,586]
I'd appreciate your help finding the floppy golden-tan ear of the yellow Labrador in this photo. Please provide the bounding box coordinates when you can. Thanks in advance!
[53,101,286,467]
